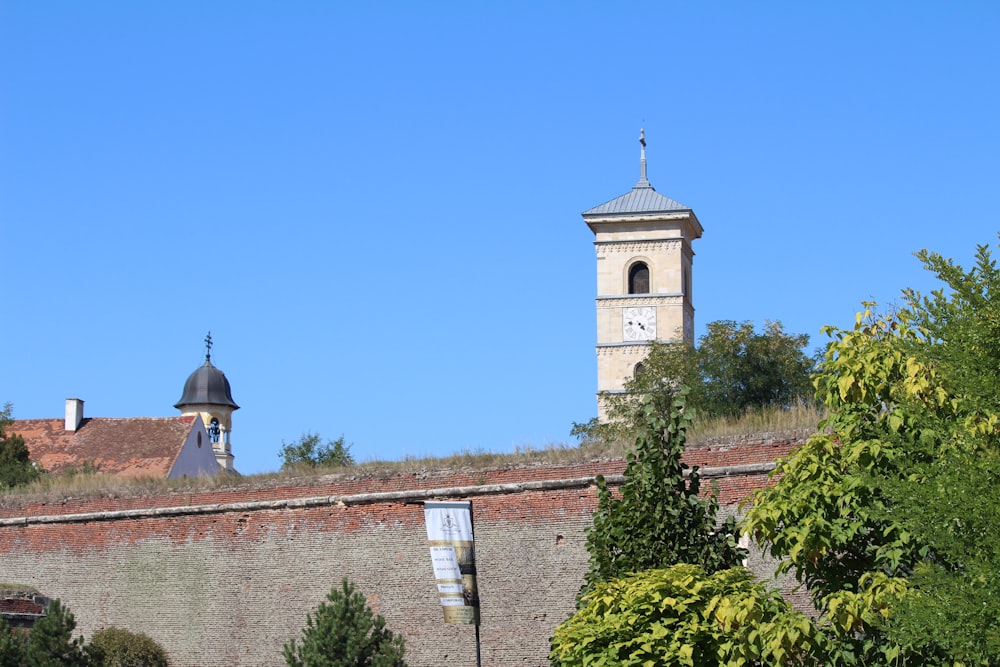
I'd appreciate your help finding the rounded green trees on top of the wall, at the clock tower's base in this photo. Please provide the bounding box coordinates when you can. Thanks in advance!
[588,320,815,439]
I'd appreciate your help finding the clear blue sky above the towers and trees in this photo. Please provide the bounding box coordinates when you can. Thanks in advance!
[0,0,1000,473]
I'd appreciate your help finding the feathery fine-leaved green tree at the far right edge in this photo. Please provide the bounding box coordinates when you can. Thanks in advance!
[873,246,1000,665]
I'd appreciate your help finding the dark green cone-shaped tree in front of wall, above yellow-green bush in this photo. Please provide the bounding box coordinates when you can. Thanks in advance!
[582,391,746,592]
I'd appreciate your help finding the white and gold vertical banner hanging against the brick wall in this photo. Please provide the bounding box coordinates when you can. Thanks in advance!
[424,501,479,625]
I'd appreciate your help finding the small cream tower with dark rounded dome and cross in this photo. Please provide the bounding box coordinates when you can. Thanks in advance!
[174,331,240,472]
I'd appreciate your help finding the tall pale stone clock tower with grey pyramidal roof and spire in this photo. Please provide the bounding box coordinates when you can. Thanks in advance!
[583,130,704,420]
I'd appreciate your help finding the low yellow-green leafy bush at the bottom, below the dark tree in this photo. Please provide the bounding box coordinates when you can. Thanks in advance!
[549,564,823,667]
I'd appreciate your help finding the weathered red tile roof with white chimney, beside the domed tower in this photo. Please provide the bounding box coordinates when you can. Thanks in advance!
[8,415,197,477]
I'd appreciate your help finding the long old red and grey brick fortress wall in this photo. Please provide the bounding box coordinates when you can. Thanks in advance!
[0,436,800,667]
